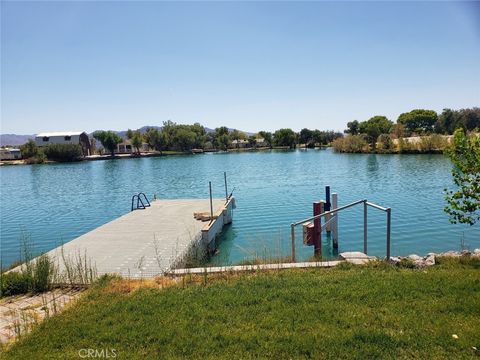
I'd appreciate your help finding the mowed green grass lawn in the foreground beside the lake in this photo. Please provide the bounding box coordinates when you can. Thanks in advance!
[3,260,480,360]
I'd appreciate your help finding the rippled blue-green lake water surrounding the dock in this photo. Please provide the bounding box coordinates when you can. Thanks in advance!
[0,150,480,266]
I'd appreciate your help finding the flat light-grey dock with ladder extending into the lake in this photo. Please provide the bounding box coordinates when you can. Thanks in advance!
[44,198,235,278]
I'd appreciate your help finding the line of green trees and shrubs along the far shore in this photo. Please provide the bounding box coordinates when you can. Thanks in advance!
[1,107,480,164]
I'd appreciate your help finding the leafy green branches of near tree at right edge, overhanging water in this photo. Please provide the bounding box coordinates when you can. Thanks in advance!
[444,129,480,225]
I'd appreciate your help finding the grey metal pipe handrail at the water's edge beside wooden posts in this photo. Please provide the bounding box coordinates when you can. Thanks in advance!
[290,199,392,262]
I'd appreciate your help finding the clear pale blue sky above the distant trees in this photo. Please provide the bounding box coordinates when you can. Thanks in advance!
[0,1,480,134]
